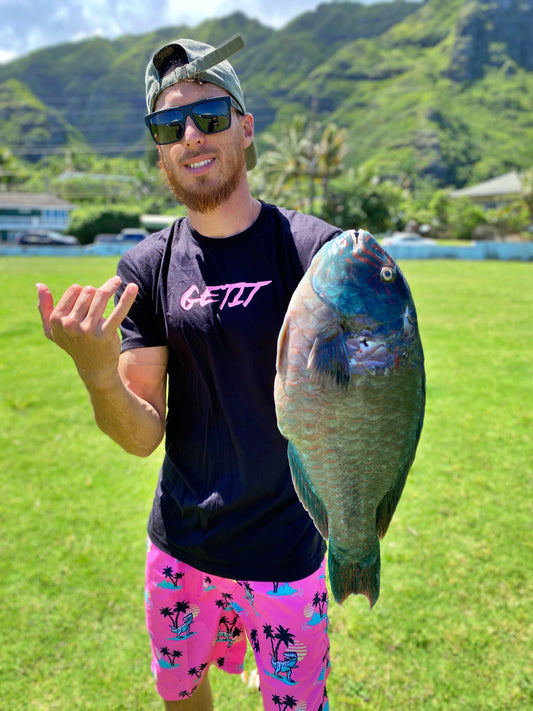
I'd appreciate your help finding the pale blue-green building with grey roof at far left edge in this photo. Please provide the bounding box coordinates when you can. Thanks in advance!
[0,191,76,242]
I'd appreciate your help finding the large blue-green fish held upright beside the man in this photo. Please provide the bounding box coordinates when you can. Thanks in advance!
[274,230,426,608]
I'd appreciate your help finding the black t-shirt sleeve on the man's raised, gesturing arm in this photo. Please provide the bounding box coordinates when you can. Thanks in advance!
[115,238,168,351]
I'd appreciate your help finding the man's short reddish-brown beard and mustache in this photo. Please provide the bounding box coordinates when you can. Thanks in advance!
[159,151,246,213]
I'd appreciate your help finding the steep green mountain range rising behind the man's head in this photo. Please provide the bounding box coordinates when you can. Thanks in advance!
[0,0,533,187]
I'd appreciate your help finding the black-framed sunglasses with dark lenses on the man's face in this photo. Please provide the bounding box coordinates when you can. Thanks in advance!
[144,96,240,146]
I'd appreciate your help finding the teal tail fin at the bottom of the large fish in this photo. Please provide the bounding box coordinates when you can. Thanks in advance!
[328,539,381,608]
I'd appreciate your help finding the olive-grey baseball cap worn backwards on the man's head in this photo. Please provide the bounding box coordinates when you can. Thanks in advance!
[145,35,257,170]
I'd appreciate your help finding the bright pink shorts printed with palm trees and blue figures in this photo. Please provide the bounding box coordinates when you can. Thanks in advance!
[145,542,329,711]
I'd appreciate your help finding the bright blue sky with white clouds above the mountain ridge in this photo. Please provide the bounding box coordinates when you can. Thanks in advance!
[0,0,400,62]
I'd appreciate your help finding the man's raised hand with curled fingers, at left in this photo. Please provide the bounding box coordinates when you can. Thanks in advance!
[36,276,138,389]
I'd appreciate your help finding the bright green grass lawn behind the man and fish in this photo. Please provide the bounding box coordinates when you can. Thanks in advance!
[0,258,533,711]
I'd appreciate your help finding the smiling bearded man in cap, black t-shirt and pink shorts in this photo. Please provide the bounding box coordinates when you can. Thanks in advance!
[37,38,340,711]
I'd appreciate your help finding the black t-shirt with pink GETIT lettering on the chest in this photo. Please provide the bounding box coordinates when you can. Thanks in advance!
[118,204,340,581]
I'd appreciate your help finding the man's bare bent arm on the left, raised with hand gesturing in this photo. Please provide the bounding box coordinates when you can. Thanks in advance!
[37,277,168,456]
